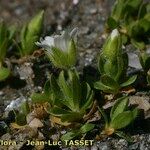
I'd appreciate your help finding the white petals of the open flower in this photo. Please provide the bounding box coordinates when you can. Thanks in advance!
[36,28,78,53]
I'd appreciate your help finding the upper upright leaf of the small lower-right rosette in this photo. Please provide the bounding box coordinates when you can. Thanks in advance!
[110,96,129,120]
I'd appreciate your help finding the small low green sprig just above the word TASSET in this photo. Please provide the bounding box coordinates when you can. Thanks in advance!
[61,123,95,141]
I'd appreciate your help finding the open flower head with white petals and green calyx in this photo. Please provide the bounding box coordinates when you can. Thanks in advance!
[37,28,77,69]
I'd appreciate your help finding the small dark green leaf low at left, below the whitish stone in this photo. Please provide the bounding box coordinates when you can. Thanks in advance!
[15,113,27,126]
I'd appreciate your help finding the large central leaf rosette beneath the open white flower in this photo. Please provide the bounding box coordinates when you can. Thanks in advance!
[31,70,93,122]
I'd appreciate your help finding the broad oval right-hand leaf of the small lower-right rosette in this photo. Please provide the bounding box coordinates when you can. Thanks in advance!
[110,111,134,130]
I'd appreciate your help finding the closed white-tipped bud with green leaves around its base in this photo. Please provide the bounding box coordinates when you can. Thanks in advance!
[94,29,137,94]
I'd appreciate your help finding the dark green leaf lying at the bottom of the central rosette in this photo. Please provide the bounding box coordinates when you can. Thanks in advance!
[61,111,85,122]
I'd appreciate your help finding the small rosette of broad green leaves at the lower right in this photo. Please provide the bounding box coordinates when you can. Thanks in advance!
[99,96,138,141]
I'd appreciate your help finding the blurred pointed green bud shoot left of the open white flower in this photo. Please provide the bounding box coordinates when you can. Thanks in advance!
[17,11,44,57]
